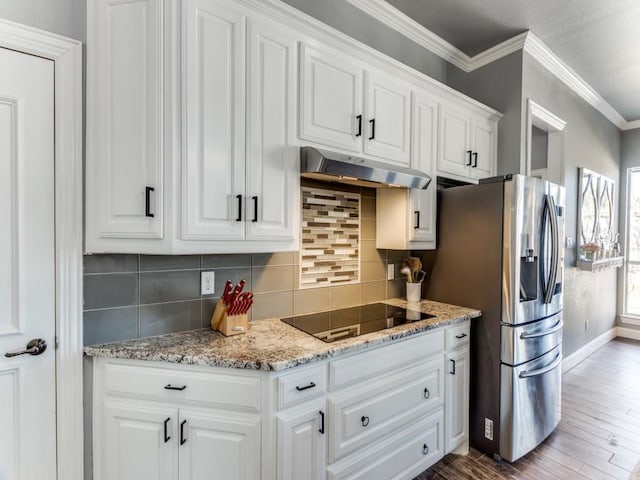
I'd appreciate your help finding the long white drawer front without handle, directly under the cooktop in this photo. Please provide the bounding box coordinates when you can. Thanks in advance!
[329,330,444,391]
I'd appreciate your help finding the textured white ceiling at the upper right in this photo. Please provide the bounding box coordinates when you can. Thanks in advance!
[387,0,640,122]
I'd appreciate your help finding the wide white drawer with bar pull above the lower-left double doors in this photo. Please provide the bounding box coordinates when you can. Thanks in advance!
[104,363,260,412]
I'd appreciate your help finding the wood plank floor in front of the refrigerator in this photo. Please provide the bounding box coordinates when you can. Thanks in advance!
[415,339,640,480]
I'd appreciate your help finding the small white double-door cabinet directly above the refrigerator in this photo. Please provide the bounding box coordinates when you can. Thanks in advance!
[437,102,498,182]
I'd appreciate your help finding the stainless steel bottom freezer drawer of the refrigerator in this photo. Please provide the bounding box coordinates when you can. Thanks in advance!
[500,345,562,462]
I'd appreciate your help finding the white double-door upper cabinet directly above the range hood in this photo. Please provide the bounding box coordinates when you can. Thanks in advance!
[299,44,411,166]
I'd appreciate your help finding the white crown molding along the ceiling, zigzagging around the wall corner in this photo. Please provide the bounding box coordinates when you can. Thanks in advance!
[346,0,640,130]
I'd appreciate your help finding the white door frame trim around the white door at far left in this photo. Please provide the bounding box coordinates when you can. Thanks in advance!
[0,19,84,480]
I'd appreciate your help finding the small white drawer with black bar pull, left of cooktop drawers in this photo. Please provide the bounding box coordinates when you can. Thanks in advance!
[276,364,327,409]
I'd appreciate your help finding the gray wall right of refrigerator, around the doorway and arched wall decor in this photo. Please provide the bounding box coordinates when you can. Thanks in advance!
[520,53,621,355]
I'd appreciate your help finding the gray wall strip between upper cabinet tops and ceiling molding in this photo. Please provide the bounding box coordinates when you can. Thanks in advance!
[283,0,448,83]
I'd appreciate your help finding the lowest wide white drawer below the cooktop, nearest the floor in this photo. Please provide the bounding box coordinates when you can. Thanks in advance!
[328,409,444,480]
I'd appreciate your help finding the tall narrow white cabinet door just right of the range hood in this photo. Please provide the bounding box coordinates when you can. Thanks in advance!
[407,94,438,248]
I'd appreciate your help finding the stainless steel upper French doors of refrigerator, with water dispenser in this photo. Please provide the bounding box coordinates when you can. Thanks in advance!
[501,175,564,325]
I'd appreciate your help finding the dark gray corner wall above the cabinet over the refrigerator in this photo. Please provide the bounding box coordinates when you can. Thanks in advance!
[447,50,522,175]
